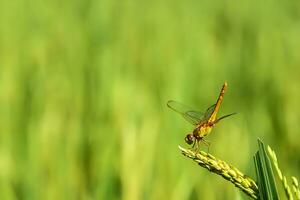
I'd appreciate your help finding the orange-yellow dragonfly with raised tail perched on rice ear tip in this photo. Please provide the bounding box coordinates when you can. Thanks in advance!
[167,82,236,150]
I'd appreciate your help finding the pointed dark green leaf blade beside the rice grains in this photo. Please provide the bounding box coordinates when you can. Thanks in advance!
[254,139,279,200]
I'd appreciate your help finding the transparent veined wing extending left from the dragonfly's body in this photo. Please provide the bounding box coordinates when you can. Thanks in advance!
[167,100,204,125]
